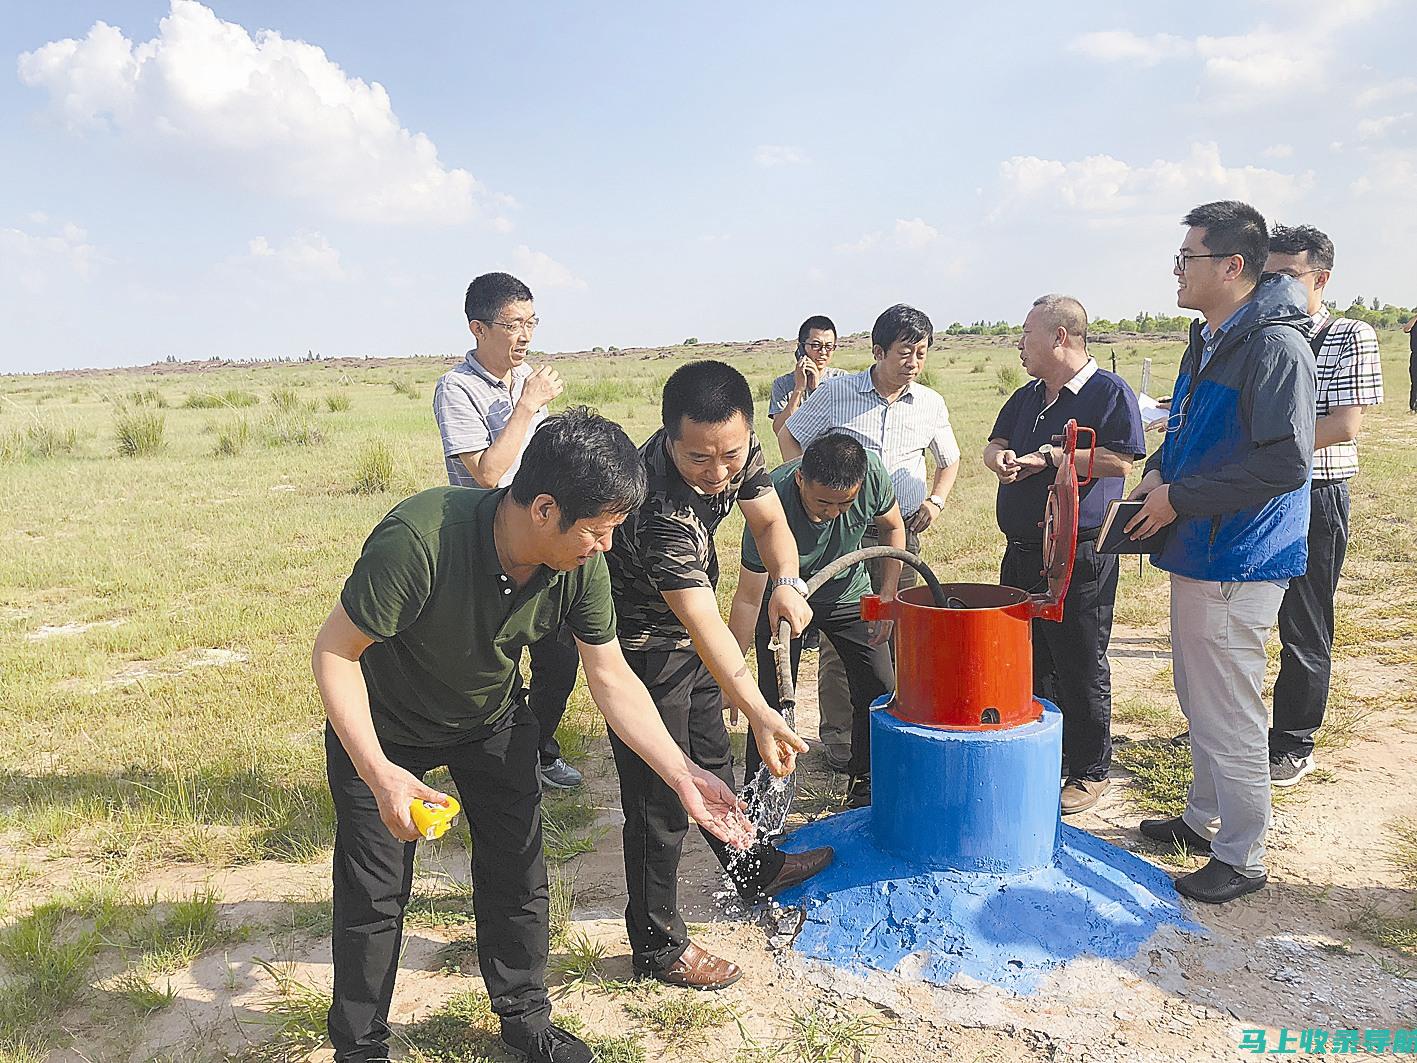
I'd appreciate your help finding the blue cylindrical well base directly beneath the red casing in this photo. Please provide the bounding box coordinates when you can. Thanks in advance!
[871,702,1063,874]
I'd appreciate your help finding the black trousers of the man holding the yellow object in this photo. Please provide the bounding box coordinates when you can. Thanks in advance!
[324,720,551,1063]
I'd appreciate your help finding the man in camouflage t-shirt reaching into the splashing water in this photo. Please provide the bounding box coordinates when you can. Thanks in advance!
[606,361,832,989]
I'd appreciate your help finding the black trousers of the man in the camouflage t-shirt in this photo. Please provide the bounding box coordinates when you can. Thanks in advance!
[611,649,785,975]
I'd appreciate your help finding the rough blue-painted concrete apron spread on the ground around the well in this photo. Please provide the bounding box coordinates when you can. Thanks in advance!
[777,816,1204,994]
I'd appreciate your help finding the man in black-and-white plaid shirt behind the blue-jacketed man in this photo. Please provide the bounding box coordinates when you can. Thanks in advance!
[1264,225,1383,787]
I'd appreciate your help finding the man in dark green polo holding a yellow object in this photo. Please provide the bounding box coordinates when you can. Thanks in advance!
[313,408,752,1063]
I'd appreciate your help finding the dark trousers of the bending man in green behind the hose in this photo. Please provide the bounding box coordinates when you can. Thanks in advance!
[743,598,896,785]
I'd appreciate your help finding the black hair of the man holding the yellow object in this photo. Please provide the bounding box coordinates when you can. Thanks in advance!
[510,405,648,532]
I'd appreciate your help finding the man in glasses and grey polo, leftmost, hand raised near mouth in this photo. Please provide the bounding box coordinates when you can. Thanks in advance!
[434,274,584,789]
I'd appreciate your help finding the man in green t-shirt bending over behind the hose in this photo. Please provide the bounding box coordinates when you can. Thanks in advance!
[728,432,905,808]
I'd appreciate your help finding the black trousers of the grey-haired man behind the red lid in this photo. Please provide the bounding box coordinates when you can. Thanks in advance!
[999,534,1117,780]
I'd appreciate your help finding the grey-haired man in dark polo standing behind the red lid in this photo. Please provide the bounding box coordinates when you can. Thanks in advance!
[983,295,1146,815]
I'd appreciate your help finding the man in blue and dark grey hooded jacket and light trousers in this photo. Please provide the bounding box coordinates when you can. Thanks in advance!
[1128,200,1316,904]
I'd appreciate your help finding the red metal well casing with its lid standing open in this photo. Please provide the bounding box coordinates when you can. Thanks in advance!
[862,421,1095,730]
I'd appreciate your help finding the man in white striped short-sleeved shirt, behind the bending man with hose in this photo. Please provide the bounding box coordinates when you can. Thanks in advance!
[778,303,959,771]
